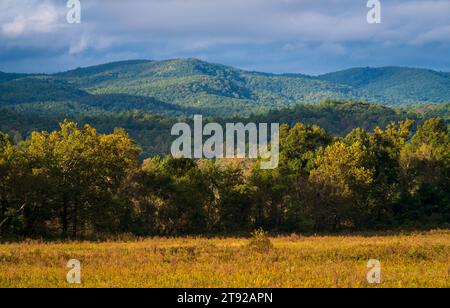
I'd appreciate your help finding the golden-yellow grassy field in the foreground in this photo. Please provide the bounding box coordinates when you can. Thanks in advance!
[0,231,450,287]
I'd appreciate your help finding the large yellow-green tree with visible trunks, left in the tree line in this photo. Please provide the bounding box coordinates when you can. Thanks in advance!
[26,121,139,239]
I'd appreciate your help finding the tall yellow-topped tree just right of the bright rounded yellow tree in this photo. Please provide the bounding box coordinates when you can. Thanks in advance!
[344,120,413,228]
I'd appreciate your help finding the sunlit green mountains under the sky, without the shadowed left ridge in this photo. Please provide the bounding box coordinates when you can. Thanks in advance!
[54,59,450,115]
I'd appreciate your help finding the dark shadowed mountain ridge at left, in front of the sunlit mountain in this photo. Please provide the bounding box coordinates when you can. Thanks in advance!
[0,76,192,116]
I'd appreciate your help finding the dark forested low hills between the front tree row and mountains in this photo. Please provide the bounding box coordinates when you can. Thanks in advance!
[0,101,450,160]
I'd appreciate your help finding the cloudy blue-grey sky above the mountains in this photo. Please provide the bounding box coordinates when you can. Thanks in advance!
[0,0,450,75]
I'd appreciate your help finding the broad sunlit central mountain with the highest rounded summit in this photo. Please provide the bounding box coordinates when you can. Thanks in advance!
[55,59,357,114]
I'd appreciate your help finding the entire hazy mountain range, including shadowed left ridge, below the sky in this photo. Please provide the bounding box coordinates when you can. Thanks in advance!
[0,59,450,117]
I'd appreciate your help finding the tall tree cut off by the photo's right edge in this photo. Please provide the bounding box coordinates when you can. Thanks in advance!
[400,118,450,226]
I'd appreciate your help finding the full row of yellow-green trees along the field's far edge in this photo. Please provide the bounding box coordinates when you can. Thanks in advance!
[0,118,450,239]
